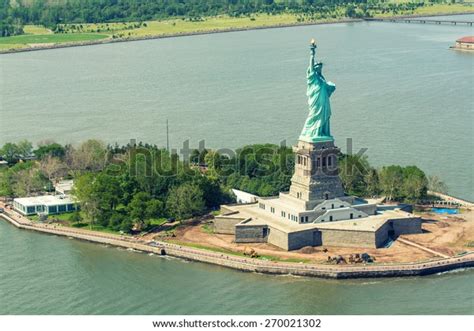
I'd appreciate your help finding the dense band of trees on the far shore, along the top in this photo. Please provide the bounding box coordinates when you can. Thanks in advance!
[0,0,445,36]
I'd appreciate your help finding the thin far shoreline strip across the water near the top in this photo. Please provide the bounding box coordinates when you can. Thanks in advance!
[0,11,474,55]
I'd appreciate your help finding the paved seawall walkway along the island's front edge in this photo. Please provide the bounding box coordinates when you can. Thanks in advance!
[0,211,474,279]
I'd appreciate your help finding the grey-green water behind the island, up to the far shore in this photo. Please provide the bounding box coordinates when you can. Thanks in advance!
[0,15,474,200]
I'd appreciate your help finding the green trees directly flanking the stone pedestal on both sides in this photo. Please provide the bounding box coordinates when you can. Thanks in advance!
[191,144,447,202]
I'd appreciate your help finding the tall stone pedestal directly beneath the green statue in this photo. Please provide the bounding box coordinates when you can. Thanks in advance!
[289,140,344,209]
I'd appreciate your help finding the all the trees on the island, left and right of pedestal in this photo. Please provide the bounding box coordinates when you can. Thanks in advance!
[0,140,446,232]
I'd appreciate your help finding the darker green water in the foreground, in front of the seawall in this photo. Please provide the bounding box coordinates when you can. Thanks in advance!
[0,221,474,314]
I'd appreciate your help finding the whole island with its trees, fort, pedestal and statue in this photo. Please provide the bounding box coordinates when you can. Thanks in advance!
[0,40,474,278]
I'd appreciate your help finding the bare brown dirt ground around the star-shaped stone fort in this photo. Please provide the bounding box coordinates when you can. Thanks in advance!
[156,211,474,263]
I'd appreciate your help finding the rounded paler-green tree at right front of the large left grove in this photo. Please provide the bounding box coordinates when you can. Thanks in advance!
[166,183,205,220]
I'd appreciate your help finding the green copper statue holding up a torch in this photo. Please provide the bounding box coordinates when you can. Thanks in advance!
[299,39,336,143]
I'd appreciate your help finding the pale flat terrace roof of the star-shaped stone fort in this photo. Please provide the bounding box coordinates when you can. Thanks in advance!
[224,204,413,233]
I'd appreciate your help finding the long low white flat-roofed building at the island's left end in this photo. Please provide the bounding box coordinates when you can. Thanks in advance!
[13,195,76,216]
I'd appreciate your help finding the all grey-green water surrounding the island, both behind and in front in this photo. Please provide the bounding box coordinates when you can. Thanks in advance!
[0,15,474,314]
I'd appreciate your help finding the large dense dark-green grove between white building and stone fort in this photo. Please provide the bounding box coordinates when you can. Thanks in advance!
[74,144,231,232]
